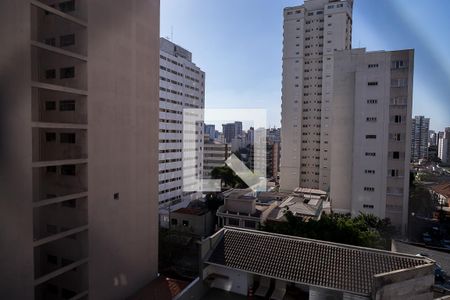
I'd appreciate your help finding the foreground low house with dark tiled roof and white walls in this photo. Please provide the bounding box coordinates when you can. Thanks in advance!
[176,227,435,300]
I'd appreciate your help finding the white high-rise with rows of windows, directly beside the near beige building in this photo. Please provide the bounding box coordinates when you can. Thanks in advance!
[159,38,205,206]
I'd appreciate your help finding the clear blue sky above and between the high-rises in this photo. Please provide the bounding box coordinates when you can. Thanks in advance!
[161,0,450,130]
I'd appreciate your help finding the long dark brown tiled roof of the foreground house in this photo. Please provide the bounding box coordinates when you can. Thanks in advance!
[207,228,430,295]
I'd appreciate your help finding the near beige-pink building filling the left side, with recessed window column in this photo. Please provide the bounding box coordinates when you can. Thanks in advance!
[0,0,159,299]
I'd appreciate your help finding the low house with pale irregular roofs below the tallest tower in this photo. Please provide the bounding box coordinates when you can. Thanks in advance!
[217,188,327,229]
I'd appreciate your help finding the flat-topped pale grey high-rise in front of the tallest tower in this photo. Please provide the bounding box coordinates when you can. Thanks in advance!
[330,49,414,232]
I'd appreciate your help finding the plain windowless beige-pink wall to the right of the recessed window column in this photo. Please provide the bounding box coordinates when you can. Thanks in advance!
[88,0,159,299]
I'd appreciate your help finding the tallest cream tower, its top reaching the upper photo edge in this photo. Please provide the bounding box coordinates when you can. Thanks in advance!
[280,0,353,190]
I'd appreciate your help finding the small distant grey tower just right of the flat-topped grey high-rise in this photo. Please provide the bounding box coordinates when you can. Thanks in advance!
[411,116,430,161]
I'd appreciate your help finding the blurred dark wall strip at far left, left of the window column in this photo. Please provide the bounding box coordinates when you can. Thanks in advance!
[0,0,34,299]
